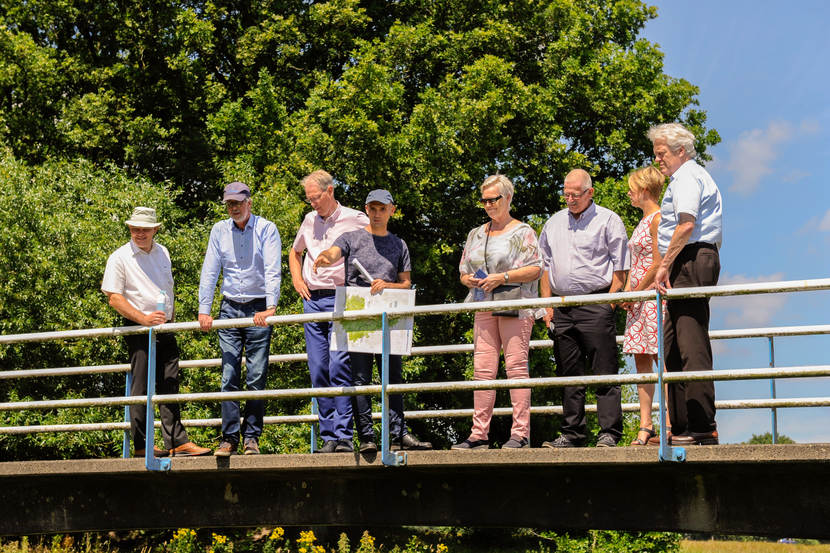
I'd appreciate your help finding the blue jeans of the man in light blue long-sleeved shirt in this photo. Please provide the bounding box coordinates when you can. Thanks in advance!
[218,298,273,443]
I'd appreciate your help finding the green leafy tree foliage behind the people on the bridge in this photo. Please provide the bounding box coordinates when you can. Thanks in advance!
[0,0,719,458]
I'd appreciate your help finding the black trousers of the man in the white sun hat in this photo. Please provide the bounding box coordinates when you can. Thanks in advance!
[124,328,190,449]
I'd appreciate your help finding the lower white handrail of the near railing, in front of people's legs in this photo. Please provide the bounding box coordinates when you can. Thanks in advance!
[0,365,830,411]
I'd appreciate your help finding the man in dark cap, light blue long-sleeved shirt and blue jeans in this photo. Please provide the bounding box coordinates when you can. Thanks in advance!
[199,182,282,457]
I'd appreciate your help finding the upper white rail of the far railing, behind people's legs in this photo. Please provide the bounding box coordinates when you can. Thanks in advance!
[0,325,830,380]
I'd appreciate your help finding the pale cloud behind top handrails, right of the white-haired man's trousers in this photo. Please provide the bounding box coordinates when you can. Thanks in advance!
[711,273,788,329]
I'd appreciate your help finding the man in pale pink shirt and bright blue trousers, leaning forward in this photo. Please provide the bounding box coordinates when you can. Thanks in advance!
[288,170,369,453]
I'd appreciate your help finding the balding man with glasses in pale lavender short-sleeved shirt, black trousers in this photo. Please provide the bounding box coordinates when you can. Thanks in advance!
[539,169,631,448]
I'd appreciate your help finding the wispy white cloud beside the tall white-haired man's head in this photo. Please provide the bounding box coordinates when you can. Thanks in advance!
[726,121,795,196]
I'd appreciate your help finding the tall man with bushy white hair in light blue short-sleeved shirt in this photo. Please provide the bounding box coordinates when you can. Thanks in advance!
[648,123,723,445]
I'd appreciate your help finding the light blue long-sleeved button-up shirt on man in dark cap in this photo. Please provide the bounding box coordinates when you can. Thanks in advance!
[199,214,282,315]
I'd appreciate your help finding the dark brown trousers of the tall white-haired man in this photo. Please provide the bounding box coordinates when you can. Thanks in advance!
[663,242,720,434]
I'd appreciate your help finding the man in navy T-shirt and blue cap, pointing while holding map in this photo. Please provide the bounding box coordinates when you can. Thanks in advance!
[314,190,432,455]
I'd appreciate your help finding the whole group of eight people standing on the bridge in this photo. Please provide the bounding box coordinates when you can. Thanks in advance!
[101,123,722,456]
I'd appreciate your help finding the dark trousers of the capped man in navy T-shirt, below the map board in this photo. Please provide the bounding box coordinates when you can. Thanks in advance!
[349,351,406,442]
